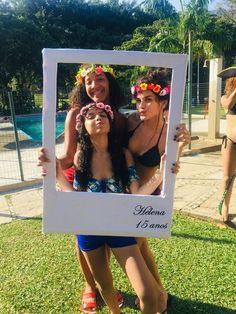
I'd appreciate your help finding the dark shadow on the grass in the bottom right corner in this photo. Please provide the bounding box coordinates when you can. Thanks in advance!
[168,296,235,314]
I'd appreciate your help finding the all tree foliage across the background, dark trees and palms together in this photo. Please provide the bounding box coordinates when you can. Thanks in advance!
[0,0,236,113]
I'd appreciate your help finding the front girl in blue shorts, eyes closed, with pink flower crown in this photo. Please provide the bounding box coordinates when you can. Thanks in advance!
[49,103,164,314]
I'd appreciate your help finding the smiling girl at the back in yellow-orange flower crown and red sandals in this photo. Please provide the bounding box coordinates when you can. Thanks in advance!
[38,64,127,313]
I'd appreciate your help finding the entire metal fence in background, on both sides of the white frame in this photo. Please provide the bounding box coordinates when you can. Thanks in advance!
[0,83,224,190]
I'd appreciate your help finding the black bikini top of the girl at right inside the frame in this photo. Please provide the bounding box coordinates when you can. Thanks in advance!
[128,122,165,167]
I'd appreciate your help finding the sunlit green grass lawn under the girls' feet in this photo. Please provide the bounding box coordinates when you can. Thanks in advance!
[0,214,236,314]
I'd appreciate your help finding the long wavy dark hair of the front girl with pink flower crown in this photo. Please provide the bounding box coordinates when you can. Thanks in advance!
[77,111,128,191]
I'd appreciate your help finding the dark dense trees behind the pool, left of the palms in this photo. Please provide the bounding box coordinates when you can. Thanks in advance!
[0,0,154,89]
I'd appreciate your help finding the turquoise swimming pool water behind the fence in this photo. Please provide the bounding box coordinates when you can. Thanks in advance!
[16,112,66,142]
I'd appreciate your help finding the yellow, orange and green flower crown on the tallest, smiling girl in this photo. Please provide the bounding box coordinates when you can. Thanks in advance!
[75,64,115,86]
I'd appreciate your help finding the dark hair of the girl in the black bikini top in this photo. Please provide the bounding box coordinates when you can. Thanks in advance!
[137,68,171,105]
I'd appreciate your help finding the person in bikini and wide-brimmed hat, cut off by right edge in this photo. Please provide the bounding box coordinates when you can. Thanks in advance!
[218,66,236,222]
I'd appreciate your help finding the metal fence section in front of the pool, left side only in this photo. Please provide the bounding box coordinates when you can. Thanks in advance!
[0,91,66,190]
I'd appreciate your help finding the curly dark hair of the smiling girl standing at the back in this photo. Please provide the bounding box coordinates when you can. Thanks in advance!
[69,72,125,111]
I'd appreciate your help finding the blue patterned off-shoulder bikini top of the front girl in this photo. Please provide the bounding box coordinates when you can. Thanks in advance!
[73,166,139,193]
